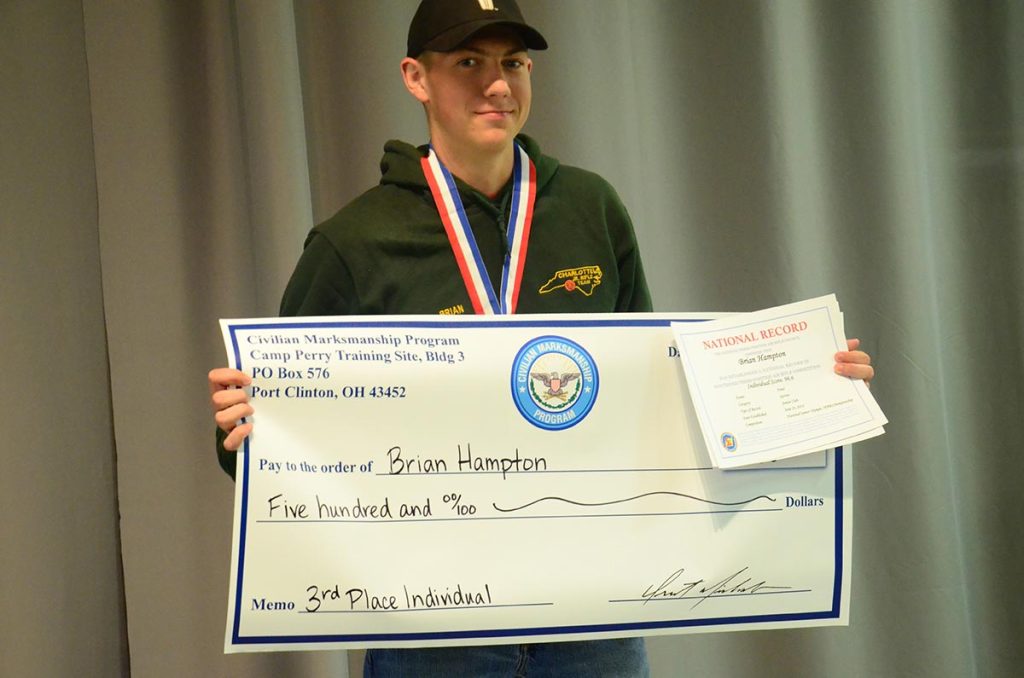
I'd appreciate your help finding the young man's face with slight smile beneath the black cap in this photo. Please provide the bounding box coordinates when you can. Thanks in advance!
[420,31,534,152]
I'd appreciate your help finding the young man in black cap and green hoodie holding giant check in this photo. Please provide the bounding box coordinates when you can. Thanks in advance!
[210,0,872,678]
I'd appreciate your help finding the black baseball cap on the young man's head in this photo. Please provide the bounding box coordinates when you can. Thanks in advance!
[406,0,548,58]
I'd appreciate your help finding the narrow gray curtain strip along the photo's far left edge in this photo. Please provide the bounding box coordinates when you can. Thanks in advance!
[0,2,128,676]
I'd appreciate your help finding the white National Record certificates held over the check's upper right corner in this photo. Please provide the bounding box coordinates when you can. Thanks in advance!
[673,295,887,468]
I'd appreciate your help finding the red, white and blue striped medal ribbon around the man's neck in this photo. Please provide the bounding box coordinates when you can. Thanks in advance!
[421,142,537,314]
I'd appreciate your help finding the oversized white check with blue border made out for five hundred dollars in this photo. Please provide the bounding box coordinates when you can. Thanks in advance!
[221,313,852,652]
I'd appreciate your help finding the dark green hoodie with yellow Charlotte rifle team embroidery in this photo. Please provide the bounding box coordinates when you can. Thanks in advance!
[217,135,651,477]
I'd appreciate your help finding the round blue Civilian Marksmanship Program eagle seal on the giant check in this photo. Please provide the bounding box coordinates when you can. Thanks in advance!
[512,336,598,431]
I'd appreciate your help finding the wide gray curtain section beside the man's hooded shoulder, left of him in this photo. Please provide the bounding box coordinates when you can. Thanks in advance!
[84,0,346,676]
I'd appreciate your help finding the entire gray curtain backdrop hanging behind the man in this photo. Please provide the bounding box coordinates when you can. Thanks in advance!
[0,0,1024,677]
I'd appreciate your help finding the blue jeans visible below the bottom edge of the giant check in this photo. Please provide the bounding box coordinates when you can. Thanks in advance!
[362,638,650,678]
